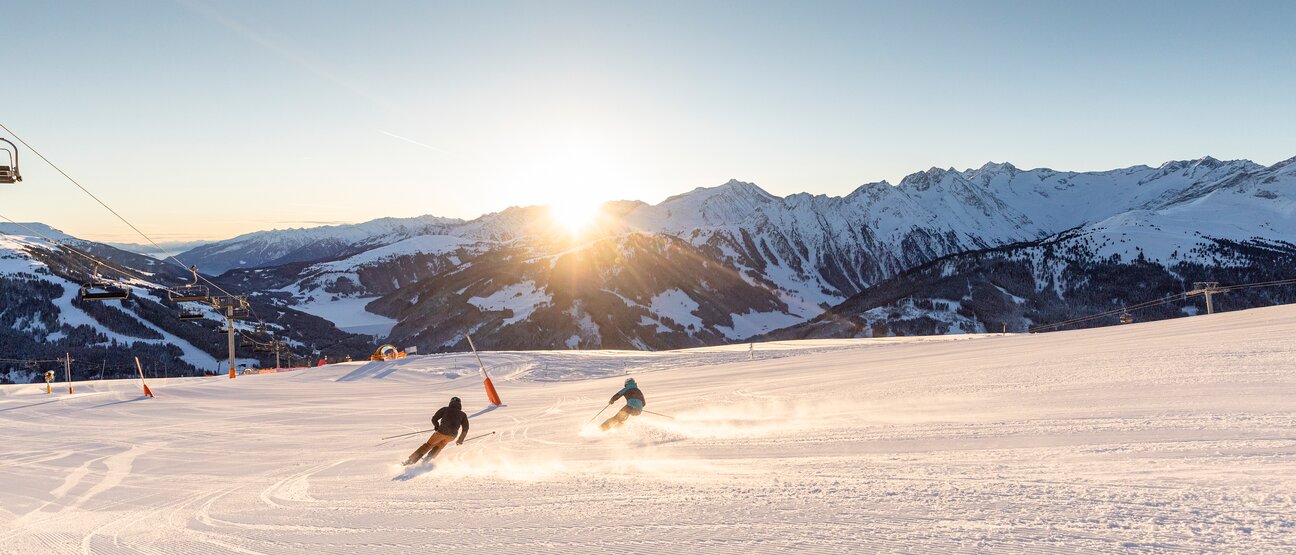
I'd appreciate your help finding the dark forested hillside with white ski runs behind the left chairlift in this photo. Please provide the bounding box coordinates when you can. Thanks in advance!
[0,224,372,381]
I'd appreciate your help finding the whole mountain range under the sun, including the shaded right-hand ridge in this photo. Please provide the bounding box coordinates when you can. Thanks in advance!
[5,157,1296,368]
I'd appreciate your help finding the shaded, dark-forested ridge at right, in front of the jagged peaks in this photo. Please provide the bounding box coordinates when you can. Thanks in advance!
[767,154,1296,338]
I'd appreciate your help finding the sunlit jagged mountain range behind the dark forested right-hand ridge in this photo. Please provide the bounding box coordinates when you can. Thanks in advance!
[191,157,1296,349]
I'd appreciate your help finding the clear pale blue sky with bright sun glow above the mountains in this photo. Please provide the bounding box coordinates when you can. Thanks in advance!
[0,0,1296,241]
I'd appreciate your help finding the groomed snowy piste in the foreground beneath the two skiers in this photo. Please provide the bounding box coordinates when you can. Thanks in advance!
[0,306,1296,555]
